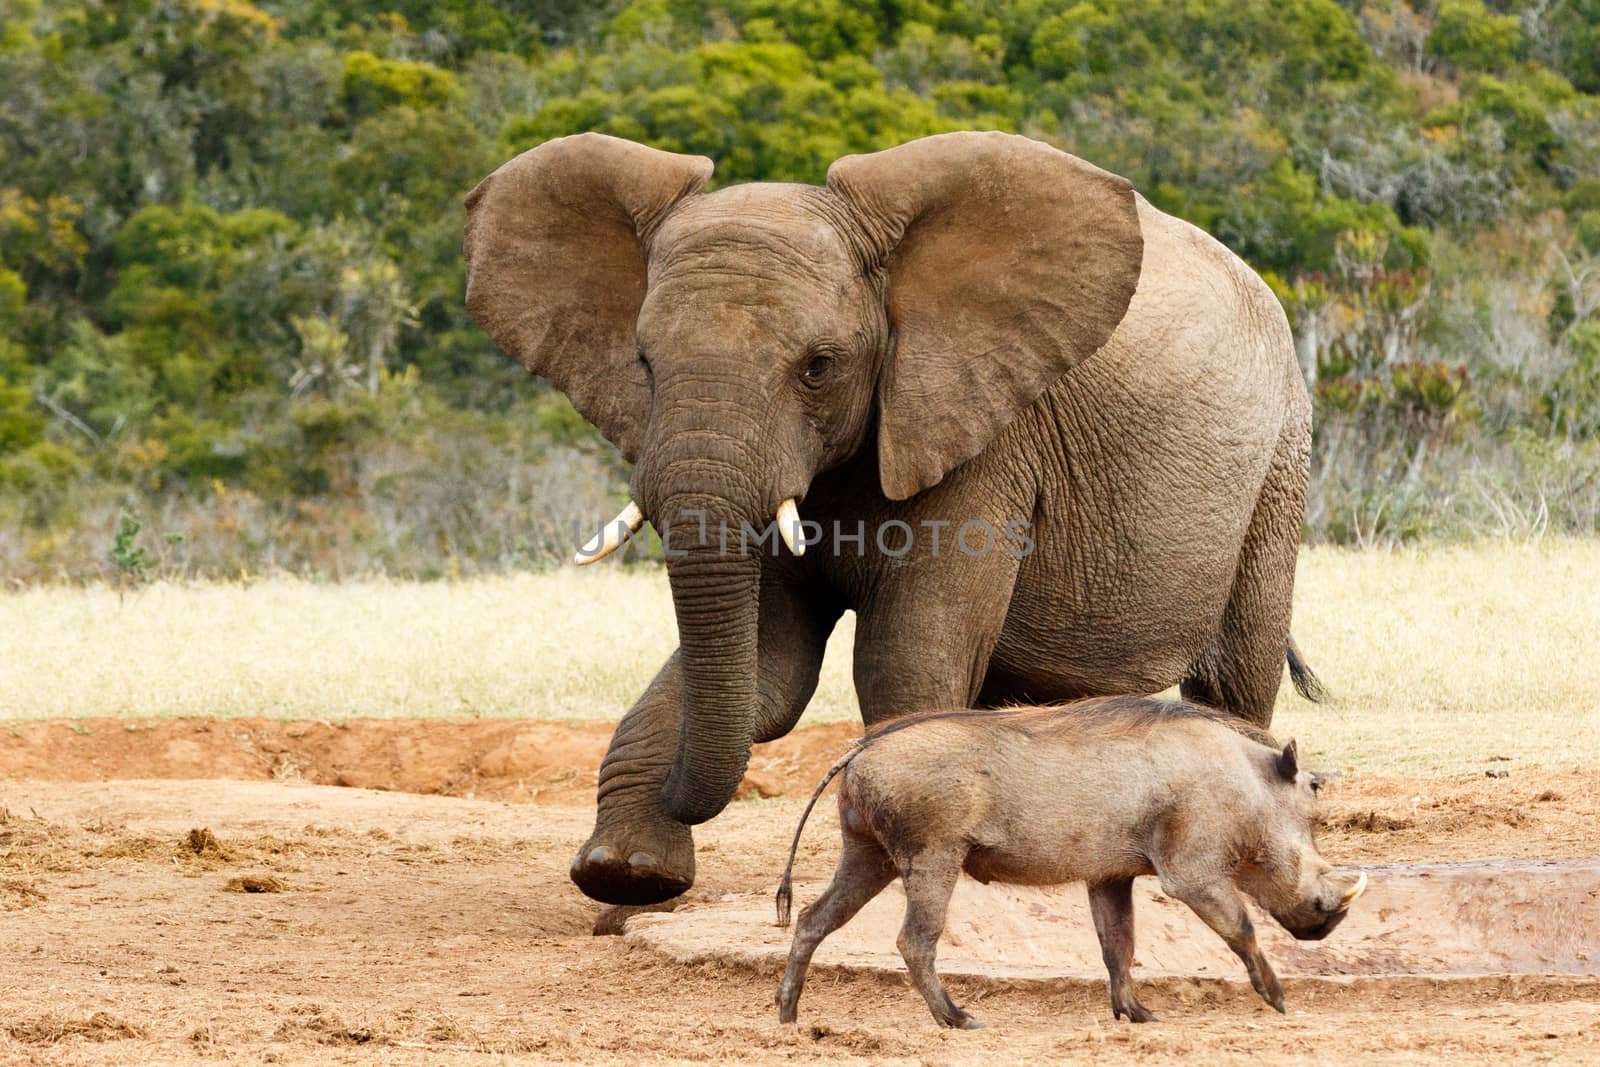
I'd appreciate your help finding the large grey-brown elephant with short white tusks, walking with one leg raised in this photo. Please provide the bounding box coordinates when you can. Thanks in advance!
[464,131,1314,904]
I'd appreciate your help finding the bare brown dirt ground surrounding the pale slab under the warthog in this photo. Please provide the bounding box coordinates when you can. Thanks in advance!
[0,720,1600,1064]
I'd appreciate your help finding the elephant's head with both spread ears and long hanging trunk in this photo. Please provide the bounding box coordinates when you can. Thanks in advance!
[466,133,1144,824]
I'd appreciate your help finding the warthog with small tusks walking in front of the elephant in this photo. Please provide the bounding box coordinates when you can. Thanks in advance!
[778,697,1366,1029]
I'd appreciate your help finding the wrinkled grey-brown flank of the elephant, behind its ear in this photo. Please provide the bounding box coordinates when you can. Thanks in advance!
[990,198,1309,699]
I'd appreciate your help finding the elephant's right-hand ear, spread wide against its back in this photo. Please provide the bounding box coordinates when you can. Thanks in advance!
[827,133,1144,501]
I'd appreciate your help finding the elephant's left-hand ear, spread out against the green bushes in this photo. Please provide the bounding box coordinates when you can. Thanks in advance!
[464,133,712,462]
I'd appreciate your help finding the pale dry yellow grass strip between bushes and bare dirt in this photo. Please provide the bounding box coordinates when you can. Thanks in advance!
[0,541,1600,774]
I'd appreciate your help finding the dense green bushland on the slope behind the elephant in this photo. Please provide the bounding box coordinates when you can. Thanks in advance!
[0,0,1600,581]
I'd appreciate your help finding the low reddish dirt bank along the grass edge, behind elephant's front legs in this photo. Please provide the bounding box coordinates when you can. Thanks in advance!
[0,718,861,805]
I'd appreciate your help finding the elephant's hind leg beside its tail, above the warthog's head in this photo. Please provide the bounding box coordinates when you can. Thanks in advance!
[1179,406,1310,728]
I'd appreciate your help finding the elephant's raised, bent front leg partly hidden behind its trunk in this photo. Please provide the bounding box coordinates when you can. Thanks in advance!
[571,568,843,904]
